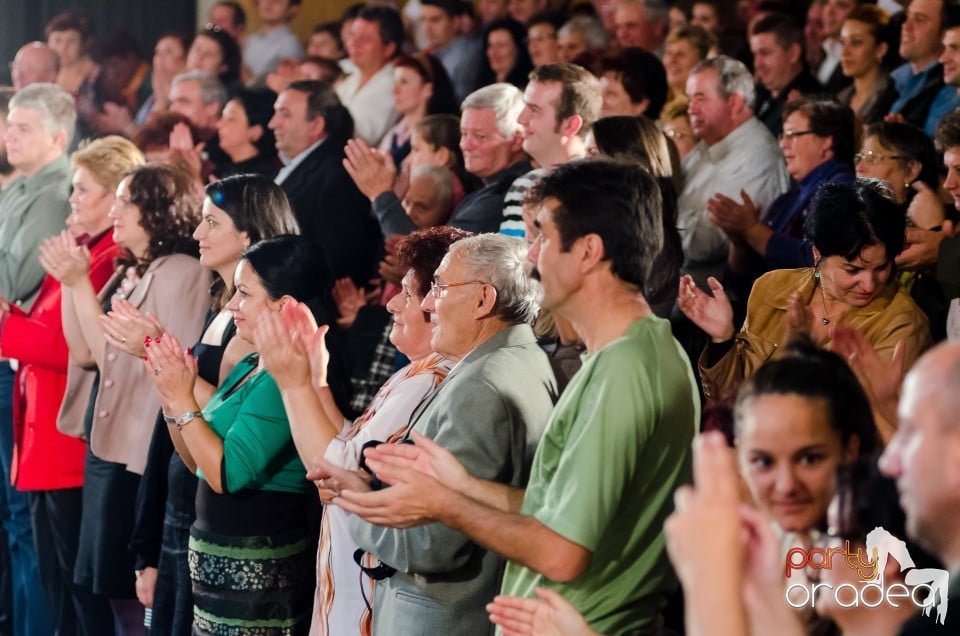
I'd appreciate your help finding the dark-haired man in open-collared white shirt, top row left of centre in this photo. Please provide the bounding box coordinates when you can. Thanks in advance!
[336,6,403,147]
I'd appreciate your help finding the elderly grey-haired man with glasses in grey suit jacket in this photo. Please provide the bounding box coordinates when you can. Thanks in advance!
[311,234,557,636]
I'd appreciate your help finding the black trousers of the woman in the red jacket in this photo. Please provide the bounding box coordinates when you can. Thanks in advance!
[30,488,112,636]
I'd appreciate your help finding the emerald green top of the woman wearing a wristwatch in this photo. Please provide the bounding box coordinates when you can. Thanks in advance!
[198,355,312,493]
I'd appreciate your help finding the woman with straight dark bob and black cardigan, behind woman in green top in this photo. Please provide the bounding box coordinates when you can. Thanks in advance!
[120,175,298,636]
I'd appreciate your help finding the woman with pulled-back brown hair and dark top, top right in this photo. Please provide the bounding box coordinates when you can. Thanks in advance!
[837,4,898,124]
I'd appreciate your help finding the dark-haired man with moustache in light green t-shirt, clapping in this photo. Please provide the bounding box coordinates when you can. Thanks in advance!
[337,161,700,634]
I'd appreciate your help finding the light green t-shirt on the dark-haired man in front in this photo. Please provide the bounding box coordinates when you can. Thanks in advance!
[502,317,700,634]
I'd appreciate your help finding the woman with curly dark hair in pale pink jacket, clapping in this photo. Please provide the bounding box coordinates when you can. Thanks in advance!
[40,165,210,634]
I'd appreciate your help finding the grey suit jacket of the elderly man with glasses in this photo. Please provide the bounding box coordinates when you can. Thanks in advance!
[350,325,557,636]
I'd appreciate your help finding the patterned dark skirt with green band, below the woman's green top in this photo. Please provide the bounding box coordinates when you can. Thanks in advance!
[189,526,314,636]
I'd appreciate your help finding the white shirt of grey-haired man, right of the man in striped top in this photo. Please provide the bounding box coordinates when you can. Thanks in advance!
[677,117,790,289]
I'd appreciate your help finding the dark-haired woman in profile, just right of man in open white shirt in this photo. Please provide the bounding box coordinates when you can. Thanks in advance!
[380,53,460,166]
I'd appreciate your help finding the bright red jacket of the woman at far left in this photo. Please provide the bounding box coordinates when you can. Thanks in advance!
[0,232,120,490]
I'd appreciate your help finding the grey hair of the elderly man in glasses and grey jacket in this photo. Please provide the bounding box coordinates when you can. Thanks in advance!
[446,234,540,325]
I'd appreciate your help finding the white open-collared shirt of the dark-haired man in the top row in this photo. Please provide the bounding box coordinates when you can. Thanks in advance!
[336,64,397,148]
